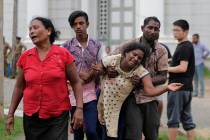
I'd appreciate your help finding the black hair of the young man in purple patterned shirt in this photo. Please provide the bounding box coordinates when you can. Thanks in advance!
[68,10,89,27]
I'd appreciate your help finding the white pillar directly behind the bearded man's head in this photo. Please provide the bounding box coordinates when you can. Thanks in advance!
[137,0,165,36]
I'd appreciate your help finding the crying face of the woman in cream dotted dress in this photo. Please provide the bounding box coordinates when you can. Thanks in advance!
[125,49,144,69]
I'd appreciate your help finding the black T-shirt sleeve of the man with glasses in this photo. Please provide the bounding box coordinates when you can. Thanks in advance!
[179,46,192,61]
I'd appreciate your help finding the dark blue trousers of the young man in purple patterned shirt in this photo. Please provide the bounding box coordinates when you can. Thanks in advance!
[71,100,98,140]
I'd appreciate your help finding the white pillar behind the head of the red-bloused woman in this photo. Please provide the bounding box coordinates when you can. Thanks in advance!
[24,0,48,48]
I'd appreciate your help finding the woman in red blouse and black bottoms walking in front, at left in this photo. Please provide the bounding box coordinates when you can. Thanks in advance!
[6,17,83,140]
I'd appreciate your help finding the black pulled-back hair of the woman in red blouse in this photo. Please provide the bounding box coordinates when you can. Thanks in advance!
[32,17,57,44]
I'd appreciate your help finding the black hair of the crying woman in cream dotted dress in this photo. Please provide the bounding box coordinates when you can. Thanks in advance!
[122,42,148,66]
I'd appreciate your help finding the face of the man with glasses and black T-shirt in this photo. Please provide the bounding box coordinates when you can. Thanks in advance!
[173,25,188,41]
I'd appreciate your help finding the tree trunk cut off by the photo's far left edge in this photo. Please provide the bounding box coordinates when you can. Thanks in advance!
[0,0,4,119]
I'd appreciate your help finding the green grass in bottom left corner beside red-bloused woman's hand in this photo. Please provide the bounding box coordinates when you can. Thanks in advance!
[0,117,23,140]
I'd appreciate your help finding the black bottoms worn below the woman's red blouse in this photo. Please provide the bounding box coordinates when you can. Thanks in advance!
[23,111,69,140]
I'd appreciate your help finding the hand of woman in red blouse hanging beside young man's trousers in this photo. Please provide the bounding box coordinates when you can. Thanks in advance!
[71,108,83,130]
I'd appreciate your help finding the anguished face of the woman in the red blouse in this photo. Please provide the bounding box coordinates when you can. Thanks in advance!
[29,19,51,45]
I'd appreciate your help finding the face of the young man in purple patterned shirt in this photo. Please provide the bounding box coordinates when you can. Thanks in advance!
[72,17,89,36]
